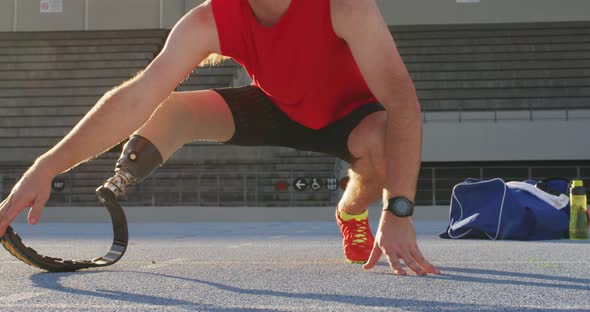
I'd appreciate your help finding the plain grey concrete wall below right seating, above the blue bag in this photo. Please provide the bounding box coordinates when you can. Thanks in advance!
[422,110,590,162]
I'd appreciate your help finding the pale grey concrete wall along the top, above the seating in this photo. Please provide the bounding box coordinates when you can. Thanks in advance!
[0,0,590,31]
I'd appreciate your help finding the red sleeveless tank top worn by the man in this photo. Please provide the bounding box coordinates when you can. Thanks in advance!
[212,0,377,129]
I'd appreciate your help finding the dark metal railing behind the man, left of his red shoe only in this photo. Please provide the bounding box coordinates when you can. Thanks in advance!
[0,168,341,206]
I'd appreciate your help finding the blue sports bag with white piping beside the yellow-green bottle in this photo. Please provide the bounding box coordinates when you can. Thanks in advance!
[439,178,570,240]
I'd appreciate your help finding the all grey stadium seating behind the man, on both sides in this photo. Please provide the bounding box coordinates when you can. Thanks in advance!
[0,22,590,206]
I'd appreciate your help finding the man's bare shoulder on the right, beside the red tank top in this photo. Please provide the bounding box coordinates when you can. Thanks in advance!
[330,0,381,39]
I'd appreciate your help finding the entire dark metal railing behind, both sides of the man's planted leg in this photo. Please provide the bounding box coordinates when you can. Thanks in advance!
[0,165,590,207]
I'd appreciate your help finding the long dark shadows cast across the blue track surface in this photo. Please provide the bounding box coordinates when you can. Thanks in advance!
[30,267,590,312]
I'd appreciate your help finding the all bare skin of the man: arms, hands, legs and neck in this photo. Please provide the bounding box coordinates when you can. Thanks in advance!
[0,0,440,275]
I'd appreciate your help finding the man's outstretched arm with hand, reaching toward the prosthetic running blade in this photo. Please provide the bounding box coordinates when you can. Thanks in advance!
[0,2,219,236]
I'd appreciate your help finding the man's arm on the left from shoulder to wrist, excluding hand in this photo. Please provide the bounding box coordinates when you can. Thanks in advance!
[40,7,217,174]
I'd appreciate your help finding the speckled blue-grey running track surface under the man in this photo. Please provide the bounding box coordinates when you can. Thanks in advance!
[0,221,590,311]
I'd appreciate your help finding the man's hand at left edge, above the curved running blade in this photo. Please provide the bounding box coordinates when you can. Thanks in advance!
[0,162,55,237]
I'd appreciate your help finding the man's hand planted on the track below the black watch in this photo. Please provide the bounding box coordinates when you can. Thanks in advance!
[363,211,441,276]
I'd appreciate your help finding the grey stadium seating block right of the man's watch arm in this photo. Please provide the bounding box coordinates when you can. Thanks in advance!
[392,22,590,111]
